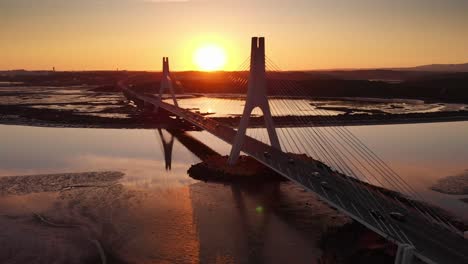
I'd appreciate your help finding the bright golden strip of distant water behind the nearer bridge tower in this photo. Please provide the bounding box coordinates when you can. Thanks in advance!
[165,95,468,117]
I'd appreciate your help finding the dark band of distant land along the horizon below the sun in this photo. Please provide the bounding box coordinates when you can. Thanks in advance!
[0,70,468,103]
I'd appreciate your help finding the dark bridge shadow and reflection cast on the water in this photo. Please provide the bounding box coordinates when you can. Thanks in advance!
[162,131,395,263]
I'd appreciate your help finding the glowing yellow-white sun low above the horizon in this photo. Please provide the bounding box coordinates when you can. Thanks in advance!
[194,45,226,71]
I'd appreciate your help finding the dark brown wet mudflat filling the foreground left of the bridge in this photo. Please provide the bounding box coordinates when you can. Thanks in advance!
[0,173,394,263]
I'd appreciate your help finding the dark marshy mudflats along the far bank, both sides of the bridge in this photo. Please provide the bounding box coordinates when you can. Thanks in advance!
[0,86,468,130]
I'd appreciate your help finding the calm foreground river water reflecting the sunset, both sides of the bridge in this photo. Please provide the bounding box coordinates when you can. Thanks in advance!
[0,122,468,263]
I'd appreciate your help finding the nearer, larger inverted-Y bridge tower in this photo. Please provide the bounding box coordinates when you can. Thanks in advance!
[228,37,281,165]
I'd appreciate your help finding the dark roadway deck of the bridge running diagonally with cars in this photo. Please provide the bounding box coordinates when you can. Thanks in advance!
[123,90,468,264]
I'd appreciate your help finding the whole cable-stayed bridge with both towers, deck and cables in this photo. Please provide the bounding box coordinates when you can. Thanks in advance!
[119,38,468,263]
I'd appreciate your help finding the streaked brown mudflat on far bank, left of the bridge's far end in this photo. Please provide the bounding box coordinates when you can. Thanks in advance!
[0,86,194,128]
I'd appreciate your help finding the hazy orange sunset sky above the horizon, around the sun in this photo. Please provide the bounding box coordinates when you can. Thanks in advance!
[0,0,468,70]
